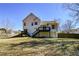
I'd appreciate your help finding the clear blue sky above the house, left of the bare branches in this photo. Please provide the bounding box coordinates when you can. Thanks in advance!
[0,3,70,30]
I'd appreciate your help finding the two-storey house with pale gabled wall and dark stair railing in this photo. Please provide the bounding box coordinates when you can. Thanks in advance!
[23,13,58,37]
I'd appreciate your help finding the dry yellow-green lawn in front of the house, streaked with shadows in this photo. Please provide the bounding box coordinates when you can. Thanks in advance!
[0,37,79,56]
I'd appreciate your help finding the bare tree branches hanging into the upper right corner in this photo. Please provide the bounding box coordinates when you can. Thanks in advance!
[66,3,79,27]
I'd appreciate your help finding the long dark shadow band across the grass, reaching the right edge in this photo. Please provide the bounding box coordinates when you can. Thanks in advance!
[11,40,79,47]
